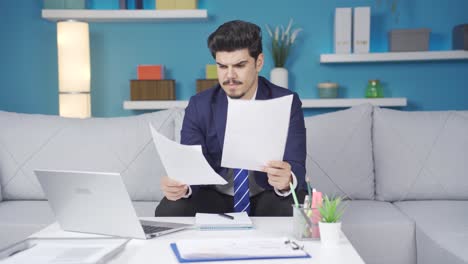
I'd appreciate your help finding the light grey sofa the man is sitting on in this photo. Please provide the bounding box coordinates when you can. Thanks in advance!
[0,105,468,264]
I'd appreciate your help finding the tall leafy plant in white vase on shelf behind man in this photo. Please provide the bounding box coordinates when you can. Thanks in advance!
[266,19,302,88]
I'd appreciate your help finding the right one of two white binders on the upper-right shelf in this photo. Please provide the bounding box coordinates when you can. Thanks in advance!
[353,7,370,53]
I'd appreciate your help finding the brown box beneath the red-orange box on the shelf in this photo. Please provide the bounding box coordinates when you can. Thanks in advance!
[130,80,175,101]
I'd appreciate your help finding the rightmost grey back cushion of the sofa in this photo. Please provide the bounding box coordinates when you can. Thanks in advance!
[373,107,468,201]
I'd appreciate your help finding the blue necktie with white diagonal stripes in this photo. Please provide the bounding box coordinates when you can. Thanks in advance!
[233,169,250,214]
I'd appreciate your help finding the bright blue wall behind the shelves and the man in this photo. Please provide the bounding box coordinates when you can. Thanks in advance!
[0,0,468,116]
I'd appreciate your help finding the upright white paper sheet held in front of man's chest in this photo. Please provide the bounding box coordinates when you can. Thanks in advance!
[221,95,293,171]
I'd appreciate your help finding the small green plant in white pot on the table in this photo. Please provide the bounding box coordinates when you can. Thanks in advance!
[318,195,344,246]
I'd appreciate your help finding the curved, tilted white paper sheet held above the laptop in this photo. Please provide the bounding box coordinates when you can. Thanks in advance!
[150,124,227,185]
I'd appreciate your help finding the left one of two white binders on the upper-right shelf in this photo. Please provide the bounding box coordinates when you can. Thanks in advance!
[335,8,352,54]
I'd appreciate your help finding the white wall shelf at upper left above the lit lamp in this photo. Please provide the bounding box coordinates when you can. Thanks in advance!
[42,9,208,22]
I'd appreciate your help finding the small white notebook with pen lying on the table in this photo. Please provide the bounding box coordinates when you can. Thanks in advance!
[195,212,253,230]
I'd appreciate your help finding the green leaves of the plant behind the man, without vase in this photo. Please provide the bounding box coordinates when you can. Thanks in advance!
[266,19,302,67]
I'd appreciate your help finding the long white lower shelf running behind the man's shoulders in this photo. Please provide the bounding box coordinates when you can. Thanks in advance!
[123,98,407,110]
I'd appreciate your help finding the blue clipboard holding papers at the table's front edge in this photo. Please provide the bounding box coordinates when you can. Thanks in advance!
[170,239,311,263]
